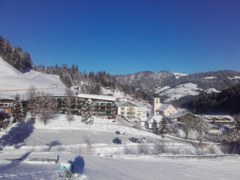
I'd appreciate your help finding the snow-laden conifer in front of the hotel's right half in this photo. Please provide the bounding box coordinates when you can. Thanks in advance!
[82,99,94,125]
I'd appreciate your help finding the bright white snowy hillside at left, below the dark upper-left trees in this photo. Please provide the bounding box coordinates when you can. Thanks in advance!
[0,57,65,99]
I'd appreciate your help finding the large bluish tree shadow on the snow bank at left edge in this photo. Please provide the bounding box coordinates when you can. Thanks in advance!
[0,121,35,151]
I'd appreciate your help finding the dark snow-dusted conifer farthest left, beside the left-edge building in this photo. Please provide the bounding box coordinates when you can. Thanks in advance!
[11,94,23,122]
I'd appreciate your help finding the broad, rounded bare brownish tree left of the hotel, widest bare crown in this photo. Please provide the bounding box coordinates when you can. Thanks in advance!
[36,92,57,125]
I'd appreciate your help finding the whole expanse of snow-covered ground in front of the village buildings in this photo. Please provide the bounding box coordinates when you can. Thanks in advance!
[0,114,240,180]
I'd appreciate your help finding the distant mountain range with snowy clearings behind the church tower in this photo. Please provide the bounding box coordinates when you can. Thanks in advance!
[114,70,240,102]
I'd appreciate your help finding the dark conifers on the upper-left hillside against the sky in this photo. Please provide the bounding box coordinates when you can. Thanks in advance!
[0,36,33,72]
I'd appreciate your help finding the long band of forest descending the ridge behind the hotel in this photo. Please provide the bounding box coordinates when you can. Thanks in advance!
[34,64,152,102]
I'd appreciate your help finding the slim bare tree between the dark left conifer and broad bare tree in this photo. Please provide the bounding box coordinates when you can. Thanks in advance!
[25,86,37,119]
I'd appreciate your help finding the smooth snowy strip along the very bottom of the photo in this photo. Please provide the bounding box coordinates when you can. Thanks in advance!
[0,153,240,180]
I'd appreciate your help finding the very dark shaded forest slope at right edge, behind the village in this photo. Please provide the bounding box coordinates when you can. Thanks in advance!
[172,84,240,114]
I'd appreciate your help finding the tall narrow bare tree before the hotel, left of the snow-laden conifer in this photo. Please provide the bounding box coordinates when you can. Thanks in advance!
[64,88,76,124]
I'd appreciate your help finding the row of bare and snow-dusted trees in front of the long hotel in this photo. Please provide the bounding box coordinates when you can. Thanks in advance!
[11,86,93,125]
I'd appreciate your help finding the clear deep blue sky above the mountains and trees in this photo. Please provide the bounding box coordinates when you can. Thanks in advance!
[0,0,240,75]
